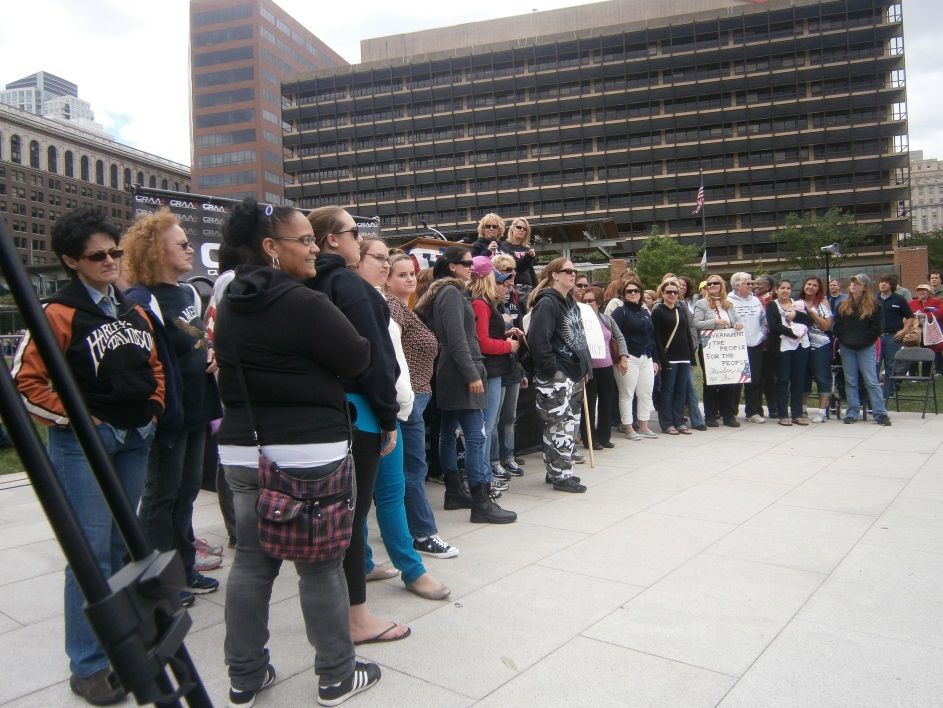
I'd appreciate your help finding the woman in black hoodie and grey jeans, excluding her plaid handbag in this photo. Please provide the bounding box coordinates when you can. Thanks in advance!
[214,199,380,705]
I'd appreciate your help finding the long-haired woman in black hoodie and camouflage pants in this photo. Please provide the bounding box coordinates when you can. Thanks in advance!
[527,258,591,493]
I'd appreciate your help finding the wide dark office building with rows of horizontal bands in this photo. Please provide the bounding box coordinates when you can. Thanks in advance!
[283,0,910,269]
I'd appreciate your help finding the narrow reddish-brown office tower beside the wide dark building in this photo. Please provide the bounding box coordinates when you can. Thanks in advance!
[190,0,347,204]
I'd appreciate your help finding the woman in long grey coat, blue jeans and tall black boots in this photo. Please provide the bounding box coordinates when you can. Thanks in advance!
[416,246,517,524]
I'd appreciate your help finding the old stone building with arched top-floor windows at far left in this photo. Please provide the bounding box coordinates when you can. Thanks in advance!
[0,104,190,267]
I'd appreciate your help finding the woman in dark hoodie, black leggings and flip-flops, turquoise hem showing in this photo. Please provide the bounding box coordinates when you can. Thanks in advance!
[305,207,410,642]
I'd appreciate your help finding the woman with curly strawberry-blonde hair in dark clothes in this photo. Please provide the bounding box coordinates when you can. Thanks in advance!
[122,209,222,604]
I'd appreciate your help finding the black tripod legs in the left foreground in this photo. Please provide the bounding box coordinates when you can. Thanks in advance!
[0,220,212,707]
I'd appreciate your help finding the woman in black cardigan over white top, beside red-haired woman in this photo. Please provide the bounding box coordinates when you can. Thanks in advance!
[766,280,814,425]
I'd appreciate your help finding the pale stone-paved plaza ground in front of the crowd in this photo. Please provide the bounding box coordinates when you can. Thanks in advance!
[0,414,943,707]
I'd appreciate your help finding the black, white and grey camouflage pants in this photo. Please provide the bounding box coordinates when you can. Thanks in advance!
[534,372,583,477]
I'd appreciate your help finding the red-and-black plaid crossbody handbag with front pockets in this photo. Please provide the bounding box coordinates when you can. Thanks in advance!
[236,354,355,563]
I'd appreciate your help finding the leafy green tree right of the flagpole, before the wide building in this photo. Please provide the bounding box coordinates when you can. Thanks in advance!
[773,208,872,270]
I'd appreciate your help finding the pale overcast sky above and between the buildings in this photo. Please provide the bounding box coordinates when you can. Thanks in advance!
[0,0,943,164]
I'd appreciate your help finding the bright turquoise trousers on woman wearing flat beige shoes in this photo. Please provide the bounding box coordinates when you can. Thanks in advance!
[363,422,426,583]
